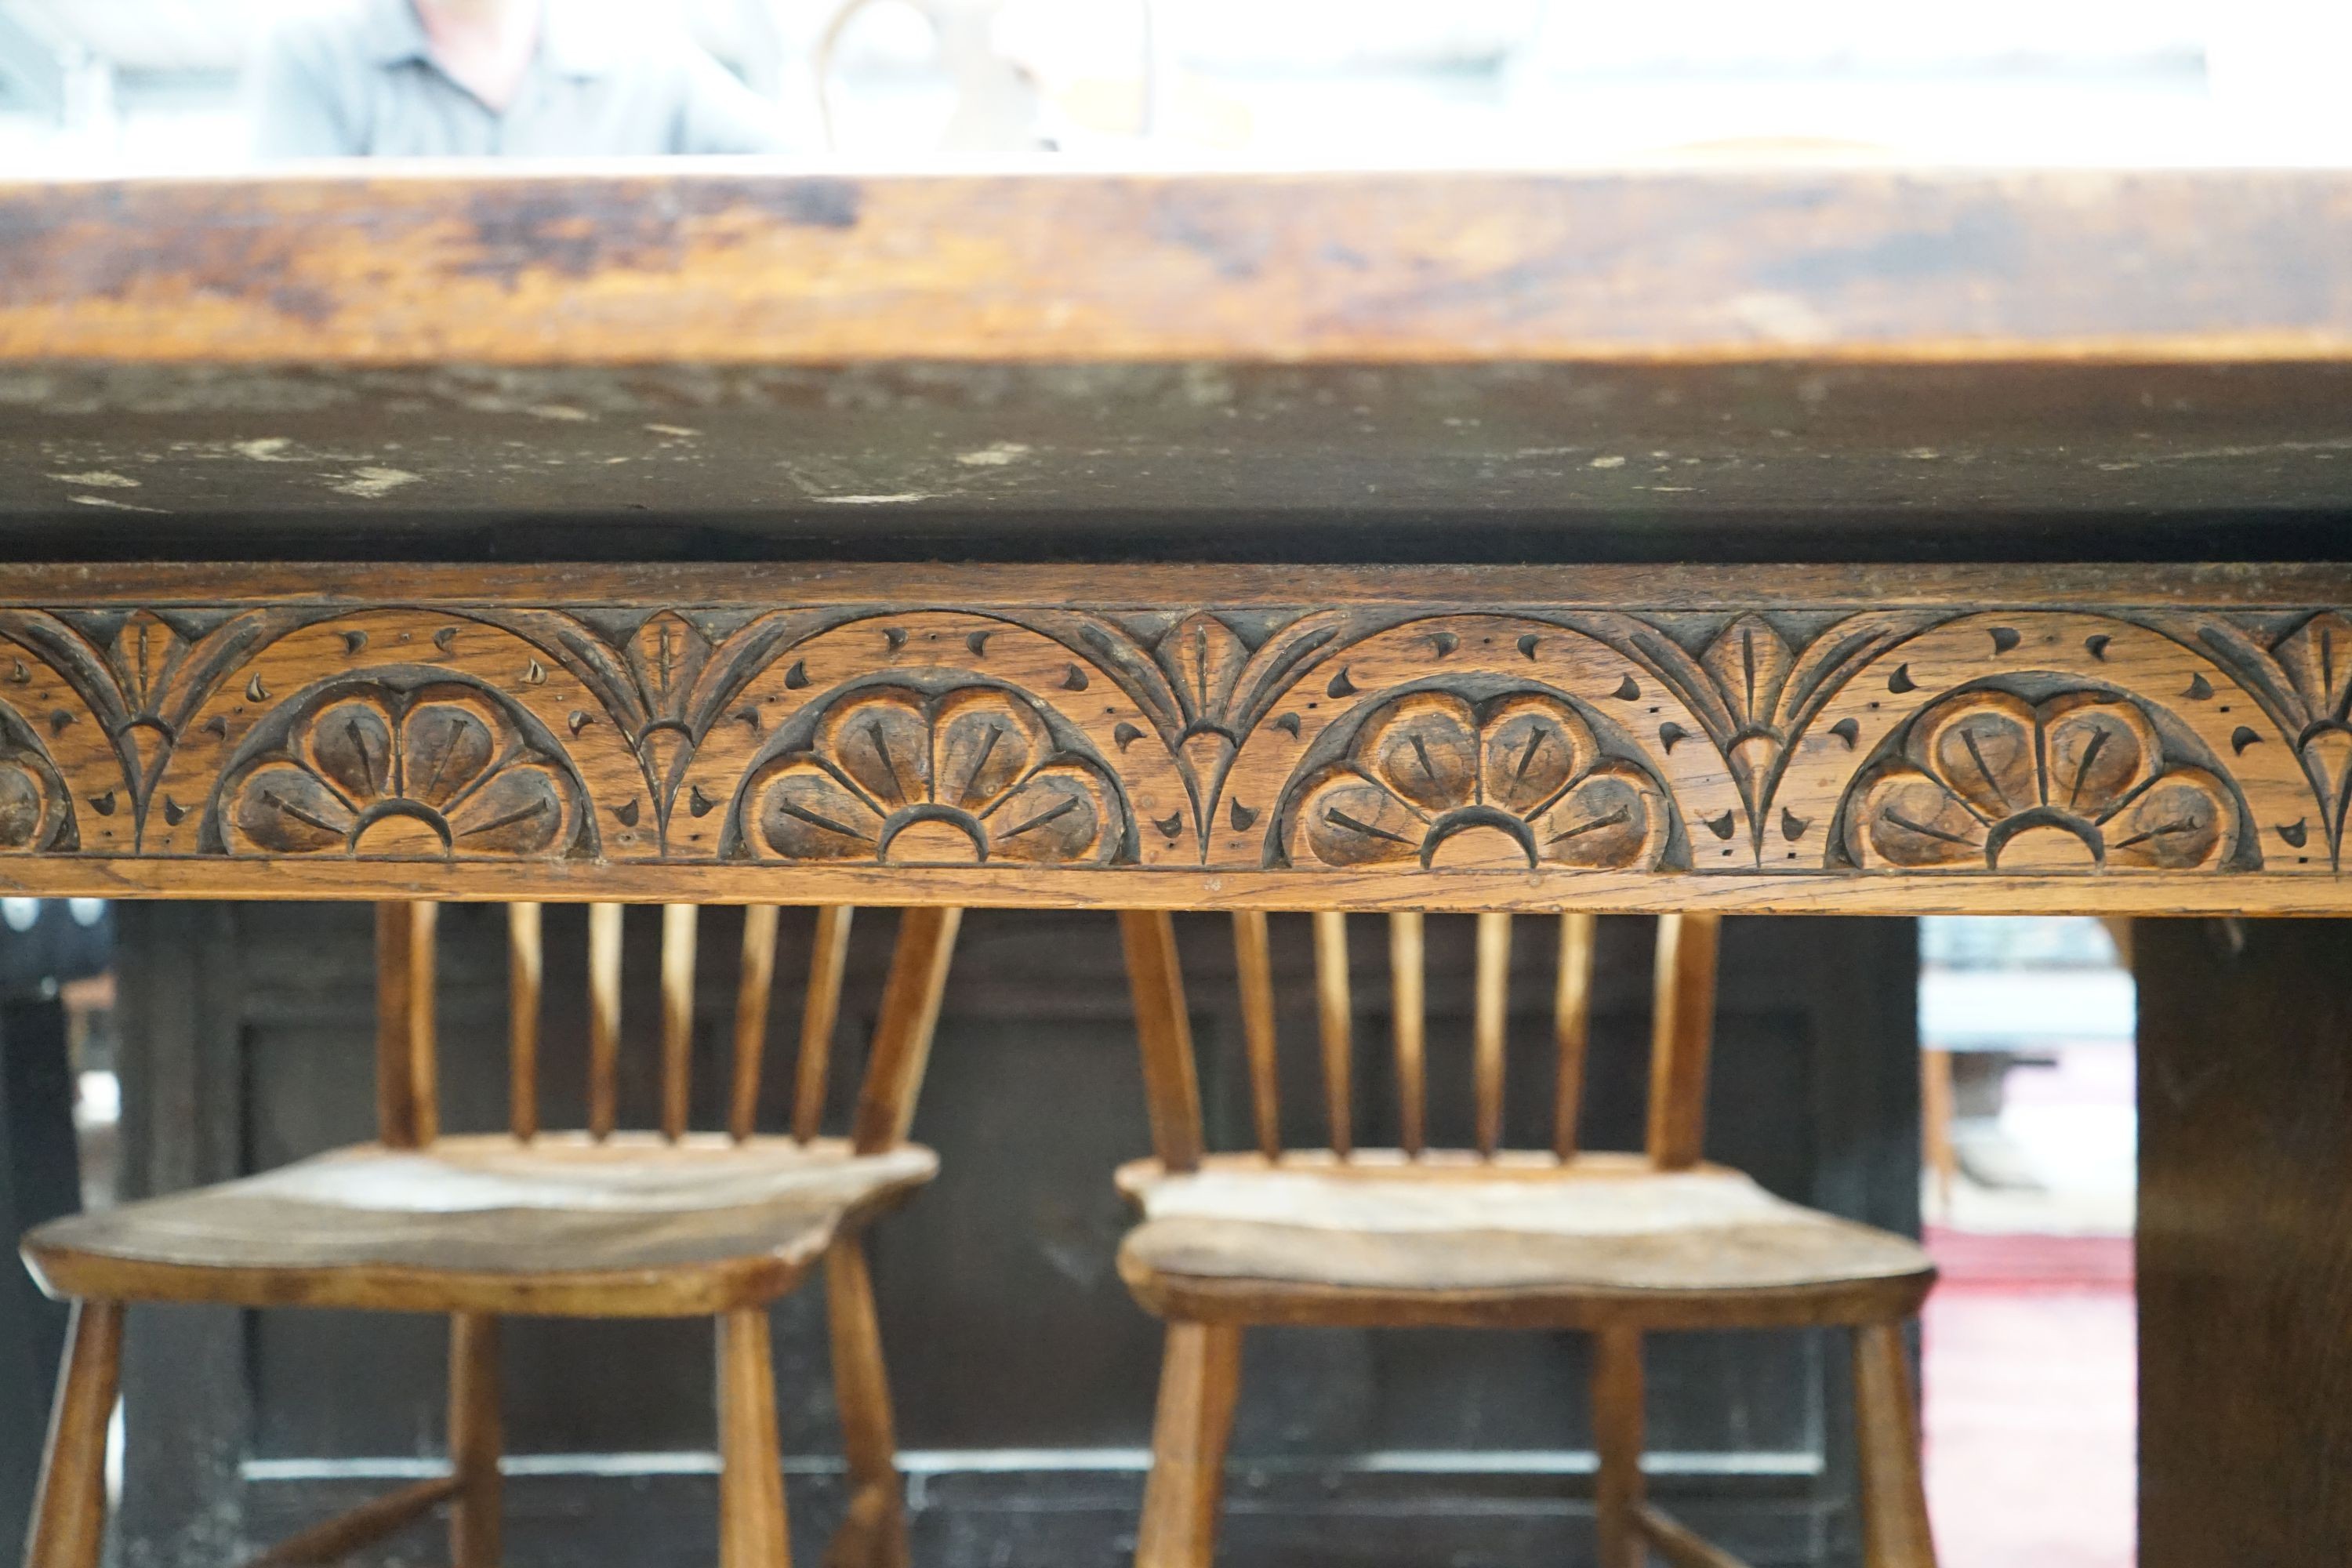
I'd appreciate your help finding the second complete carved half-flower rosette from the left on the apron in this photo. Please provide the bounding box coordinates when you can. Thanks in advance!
[739,684,1134,865]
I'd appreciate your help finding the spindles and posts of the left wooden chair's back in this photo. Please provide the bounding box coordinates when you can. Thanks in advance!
[376,902,962,1154]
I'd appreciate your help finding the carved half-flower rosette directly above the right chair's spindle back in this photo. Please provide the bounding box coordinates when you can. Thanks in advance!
[1284,691,1672,869]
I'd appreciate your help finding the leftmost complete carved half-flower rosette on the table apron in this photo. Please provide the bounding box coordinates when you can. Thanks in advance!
[219,682,581,858]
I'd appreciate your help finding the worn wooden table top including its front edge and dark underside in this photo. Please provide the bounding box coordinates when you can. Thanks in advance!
[0,165,2352,560]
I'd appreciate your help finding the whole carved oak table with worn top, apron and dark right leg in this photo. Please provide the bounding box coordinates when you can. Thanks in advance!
[0,162,2352,1568]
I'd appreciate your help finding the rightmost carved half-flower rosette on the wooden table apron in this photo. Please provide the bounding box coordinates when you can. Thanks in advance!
[1846,689,2239,872]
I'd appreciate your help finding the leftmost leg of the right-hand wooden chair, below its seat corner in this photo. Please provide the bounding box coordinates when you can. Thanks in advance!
[1136,1323,1242,1568]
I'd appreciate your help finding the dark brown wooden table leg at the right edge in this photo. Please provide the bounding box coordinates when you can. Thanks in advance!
[2133,919,2352,1568]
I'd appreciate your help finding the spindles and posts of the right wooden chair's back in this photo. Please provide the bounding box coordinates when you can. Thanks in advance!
[1122,909,1719,1171]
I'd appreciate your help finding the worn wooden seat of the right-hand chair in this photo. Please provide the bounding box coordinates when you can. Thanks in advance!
[1120,1149,1936,1328]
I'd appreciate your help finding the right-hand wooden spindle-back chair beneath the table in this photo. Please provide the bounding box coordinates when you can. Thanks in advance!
[1120,912,1936,1568]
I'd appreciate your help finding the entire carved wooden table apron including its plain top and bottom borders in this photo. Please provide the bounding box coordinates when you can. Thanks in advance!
[0,567,2352,912]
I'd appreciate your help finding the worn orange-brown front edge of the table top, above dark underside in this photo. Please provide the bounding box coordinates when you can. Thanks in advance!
[0,165,2352,365]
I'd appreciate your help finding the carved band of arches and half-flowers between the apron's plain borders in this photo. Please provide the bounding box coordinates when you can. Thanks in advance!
[0,587,2352,877]
